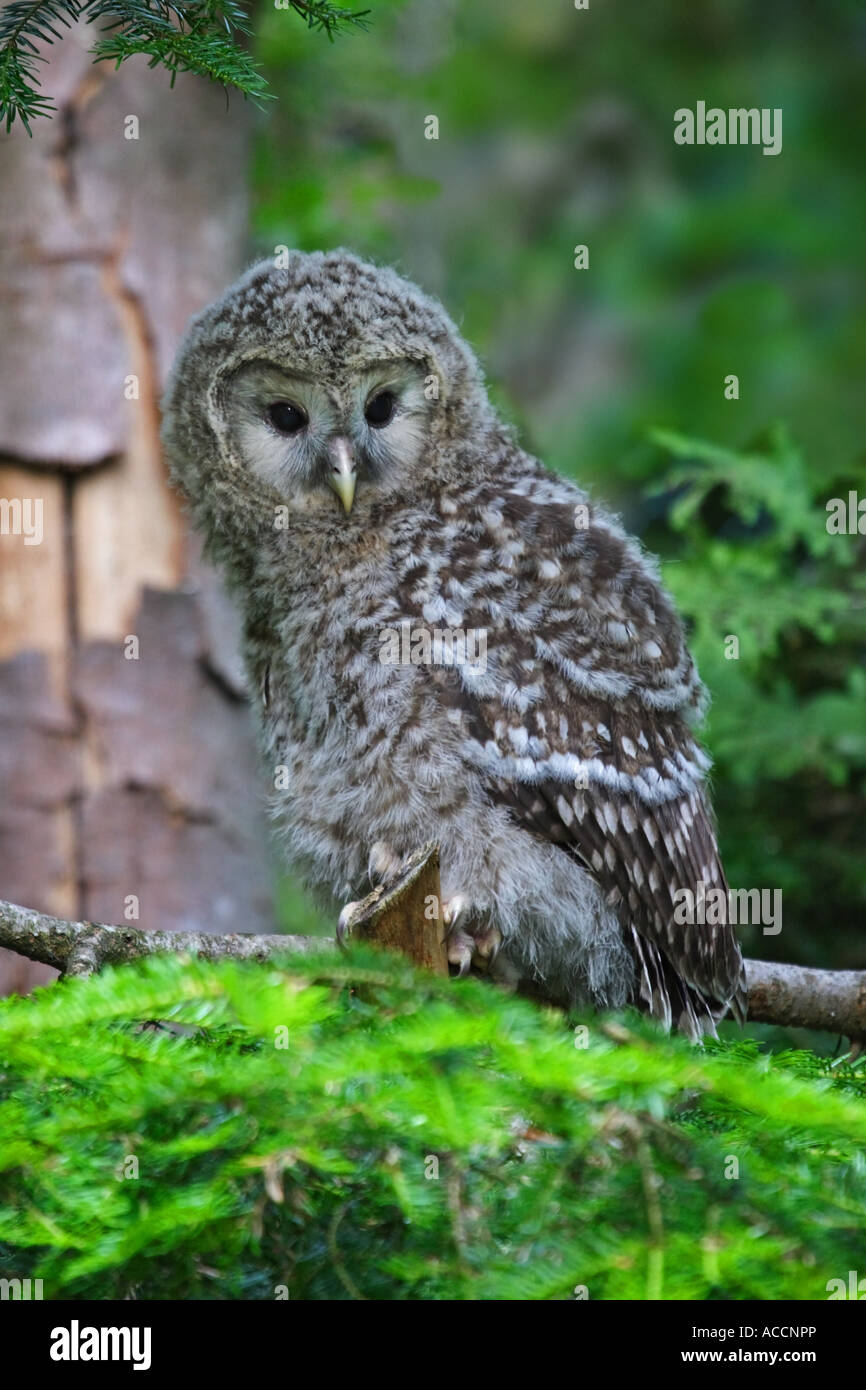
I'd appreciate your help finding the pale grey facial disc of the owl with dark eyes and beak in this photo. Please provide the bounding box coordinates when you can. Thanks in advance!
[222,357,435,513]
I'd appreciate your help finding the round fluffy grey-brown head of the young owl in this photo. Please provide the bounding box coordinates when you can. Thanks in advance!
[163,250,493,544]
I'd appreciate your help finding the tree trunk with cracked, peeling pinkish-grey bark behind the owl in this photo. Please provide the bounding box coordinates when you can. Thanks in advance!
[0,24,271,990]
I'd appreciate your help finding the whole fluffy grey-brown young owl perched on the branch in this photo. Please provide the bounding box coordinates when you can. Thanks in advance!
[163,250,745,1038]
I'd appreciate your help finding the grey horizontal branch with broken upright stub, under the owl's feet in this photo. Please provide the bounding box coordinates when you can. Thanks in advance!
[0,844,866,1043]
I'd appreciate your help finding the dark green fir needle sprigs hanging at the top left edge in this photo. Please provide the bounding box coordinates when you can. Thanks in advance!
[0,0,368,132]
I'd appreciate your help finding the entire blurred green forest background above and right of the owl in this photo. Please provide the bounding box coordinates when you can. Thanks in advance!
[253,0,866,1011]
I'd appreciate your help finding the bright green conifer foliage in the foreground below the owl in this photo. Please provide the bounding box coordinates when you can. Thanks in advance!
[0,951,866,1300]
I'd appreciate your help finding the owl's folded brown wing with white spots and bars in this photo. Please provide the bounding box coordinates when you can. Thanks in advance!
[405,466,745,1036]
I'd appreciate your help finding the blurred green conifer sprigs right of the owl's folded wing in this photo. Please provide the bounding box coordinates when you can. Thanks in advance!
[652,427,866,967]
